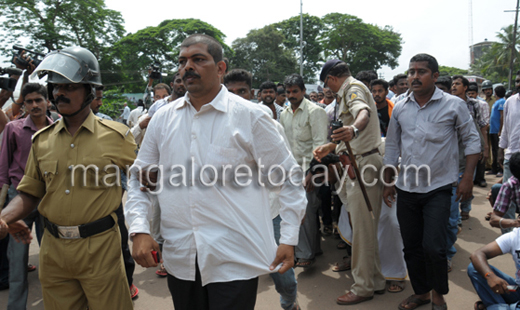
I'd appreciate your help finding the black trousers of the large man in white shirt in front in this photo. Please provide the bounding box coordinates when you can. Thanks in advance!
[168,265,258,310]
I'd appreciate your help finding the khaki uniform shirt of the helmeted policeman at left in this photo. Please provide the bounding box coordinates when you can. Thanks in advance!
[17,112,136,226]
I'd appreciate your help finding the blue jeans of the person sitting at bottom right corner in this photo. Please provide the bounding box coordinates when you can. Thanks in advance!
[468,263,520,309]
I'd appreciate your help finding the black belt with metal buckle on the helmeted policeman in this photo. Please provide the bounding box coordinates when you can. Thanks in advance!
[43,215,115,239]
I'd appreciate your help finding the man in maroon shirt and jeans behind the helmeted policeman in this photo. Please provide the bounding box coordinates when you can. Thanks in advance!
[0,83,53,309]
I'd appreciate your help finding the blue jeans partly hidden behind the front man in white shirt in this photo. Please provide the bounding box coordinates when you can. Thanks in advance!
[269,215,298,309]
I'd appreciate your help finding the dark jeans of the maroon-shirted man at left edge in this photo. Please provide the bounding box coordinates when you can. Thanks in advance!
[7,186,42,310]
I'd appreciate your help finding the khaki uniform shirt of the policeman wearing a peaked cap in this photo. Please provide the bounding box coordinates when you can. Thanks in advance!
[336,76,381,155]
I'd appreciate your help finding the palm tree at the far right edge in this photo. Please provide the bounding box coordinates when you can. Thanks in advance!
[471,25,520,84]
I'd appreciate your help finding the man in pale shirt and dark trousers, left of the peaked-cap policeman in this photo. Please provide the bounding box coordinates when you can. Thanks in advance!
[280,74,328,267]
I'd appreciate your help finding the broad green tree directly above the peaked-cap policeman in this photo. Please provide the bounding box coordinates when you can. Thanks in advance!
[321,13,402,74]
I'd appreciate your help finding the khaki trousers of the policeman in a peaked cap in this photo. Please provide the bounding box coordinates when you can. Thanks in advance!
[340,154,386,297]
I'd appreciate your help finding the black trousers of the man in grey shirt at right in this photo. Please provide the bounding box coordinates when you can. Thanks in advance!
[397,184,452,295]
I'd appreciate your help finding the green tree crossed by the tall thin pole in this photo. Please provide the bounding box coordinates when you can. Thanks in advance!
[274,14,323,83]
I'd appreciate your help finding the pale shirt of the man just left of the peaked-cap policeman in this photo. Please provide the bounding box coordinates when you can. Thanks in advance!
[280,98,329,171]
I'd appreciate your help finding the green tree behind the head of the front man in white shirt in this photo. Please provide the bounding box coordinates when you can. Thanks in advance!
[110,19,233,92]
